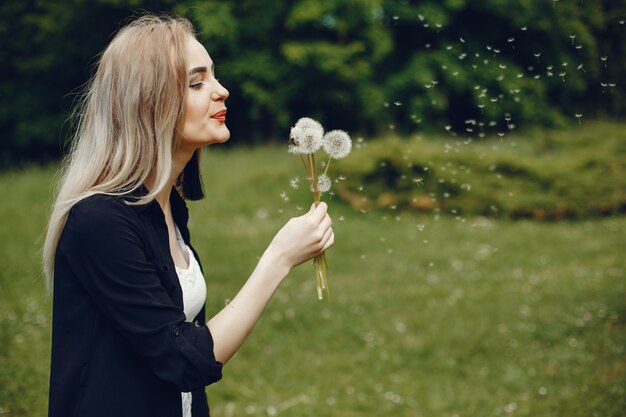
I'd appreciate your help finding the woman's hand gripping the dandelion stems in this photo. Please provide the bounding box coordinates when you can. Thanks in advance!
[264,202,335,272]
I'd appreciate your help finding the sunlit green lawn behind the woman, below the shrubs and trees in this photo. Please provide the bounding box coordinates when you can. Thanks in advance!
[0,128,626,417]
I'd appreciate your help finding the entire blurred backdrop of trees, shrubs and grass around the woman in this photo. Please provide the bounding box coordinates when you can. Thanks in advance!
[0,0,626,417]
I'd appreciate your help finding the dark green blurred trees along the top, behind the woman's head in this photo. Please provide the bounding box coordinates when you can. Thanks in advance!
[0,0,626,168]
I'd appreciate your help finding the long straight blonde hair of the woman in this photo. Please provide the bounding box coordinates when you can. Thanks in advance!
[43,15,201,289]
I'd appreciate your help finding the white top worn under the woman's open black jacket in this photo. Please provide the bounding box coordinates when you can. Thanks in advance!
[176,227,206,417]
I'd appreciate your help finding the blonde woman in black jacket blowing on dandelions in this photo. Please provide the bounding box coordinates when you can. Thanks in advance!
[44,16,334,417]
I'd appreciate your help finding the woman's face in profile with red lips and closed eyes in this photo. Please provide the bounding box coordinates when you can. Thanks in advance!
[181,37,230,151]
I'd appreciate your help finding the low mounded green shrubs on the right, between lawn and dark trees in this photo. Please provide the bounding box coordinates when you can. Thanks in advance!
[337,122,626,220]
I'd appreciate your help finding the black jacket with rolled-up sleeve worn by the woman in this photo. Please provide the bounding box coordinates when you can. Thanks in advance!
[49,187,222,417]
